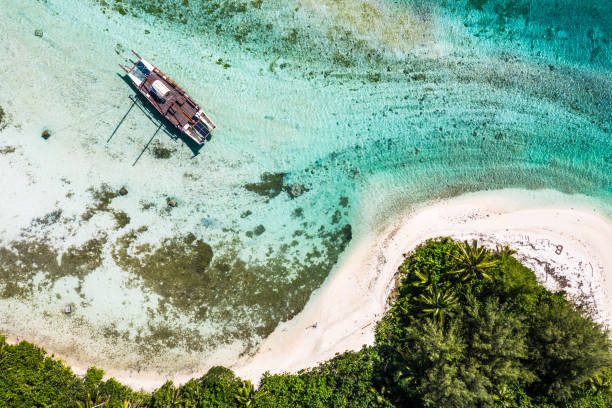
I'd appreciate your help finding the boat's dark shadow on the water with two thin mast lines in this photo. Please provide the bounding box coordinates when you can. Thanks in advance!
[106,74,212,166]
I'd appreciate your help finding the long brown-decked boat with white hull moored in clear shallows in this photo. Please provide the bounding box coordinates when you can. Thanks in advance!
[119,50,216,145]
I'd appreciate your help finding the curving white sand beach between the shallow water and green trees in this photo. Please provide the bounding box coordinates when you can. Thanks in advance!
[7,189,612,391]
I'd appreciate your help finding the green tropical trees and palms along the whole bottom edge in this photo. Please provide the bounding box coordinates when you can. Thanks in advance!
[0,238,612,408]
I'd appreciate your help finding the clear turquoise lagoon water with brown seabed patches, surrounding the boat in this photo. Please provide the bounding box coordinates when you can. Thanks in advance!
[0,0,612,371]
